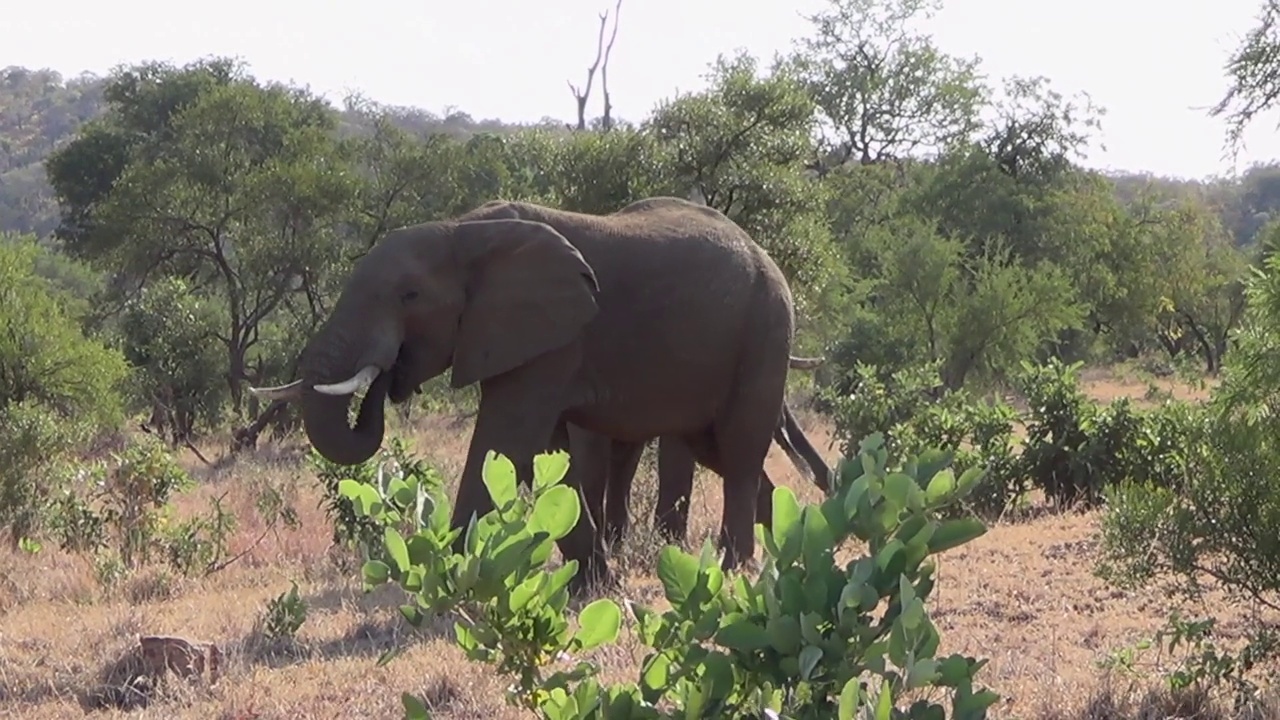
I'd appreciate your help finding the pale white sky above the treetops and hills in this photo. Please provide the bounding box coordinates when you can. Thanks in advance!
[10,0,1280,177]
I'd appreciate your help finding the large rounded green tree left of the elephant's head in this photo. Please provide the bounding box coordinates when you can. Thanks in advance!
[50,61,353,413]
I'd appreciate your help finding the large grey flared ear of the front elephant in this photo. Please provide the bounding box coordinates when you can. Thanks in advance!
[452,220,599,387]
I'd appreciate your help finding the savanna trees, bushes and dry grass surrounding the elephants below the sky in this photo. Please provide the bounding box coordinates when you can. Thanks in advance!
[0,0,1280,719]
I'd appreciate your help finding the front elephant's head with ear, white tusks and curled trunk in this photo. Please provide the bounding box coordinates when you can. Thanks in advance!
[253,219,599,465]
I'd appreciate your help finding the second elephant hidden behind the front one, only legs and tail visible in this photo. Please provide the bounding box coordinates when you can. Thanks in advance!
[588,357,831,543]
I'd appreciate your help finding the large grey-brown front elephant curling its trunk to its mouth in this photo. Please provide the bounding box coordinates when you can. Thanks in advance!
[259,197,829,589]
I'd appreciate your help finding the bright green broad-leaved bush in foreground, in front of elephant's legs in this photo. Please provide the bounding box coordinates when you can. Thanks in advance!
[339,436,997,720]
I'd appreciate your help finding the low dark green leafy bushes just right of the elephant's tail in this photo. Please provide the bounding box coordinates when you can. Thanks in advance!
[826,359,1198,518]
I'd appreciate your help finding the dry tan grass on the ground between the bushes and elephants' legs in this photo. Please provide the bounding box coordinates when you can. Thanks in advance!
[0,373,1269,720]
